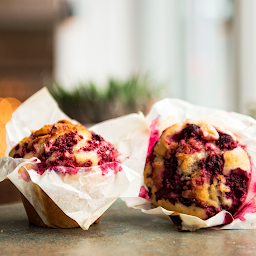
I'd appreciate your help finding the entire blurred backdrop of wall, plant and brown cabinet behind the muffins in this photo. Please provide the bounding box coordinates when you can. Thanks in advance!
[0,0,256,202]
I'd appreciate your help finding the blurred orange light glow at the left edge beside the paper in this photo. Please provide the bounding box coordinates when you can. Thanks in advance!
[0,98,21,157]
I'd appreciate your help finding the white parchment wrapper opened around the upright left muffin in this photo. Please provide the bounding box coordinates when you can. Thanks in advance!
[0,88,149,229]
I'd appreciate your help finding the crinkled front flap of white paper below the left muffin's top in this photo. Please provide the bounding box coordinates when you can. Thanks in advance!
[8,158,138,230]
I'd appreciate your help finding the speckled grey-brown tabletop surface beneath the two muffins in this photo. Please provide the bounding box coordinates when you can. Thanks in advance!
[0,200,256,256]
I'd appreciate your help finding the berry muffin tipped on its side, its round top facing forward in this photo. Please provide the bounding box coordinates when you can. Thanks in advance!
[144,120,251,220]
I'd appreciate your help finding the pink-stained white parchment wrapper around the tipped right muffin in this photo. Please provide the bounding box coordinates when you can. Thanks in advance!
[124,99,256,231]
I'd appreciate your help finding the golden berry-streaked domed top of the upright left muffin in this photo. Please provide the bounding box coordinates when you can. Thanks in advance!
[9,120,120,173]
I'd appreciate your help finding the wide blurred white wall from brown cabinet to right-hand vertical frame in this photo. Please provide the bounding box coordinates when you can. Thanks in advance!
[55,0,242,113]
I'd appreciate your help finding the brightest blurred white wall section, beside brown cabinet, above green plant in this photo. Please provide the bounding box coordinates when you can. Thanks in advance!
[55,0,138,87]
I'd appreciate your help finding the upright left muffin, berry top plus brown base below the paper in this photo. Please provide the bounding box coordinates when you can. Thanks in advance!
[9,120,120,228]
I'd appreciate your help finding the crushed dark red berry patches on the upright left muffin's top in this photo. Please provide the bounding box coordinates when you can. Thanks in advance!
[13,129,119,174]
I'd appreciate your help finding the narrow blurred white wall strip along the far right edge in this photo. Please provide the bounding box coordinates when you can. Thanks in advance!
[235,0,256,113]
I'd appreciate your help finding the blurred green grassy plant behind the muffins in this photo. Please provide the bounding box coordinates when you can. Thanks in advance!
[49,76,163,123]
